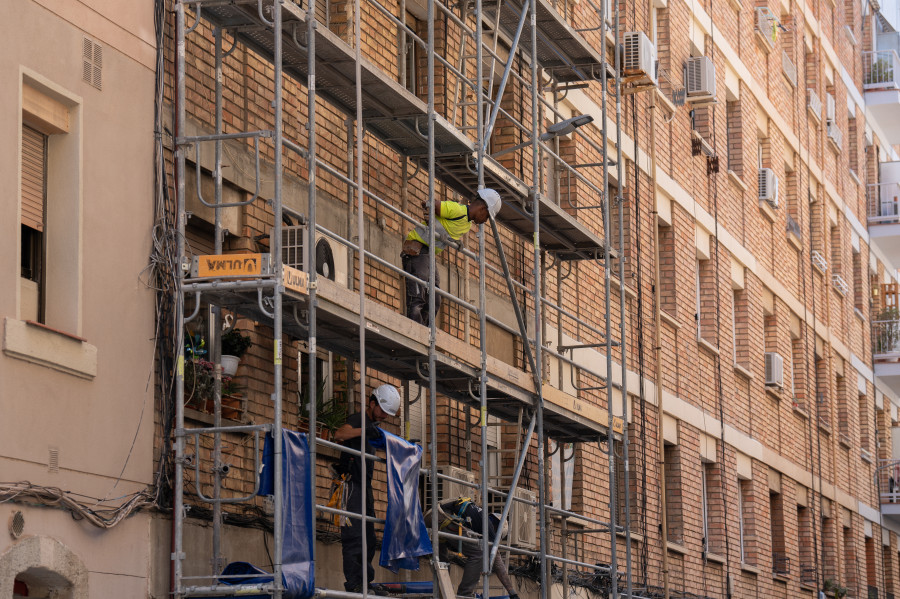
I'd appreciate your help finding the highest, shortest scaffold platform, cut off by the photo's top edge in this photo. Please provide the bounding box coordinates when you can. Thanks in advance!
[483,0,607,83]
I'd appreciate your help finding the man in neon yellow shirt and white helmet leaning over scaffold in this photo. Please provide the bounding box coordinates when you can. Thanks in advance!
[400,189,501,326]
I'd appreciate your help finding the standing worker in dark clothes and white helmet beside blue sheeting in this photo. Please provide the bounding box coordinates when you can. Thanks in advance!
[334,385,400,595]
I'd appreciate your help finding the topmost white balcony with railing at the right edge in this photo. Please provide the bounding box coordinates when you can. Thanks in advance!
[863,49,900,145]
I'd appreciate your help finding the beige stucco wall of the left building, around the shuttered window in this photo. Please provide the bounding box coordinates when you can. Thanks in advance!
[0,0,154,597]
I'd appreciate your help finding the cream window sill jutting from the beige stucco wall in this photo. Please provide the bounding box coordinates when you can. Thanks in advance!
[3,318,97,380]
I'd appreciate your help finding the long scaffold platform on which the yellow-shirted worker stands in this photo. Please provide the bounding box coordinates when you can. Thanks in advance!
[185,277,618,442]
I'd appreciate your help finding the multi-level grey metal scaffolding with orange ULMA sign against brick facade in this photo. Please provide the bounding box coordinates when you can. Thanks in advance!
[172,0,636,599]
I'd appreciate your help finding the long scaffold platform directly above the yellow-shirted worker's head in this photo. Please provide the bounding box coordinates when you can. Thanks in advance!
[194,2,603,260]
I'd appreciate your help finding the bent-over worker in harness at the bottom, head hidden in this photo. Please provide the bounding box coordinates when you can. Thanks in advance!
[440,497,519,599]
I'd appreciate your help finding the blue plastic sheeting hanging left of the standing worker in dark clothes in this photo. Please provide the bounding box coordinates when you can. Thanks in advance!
[259,431,316,599]
